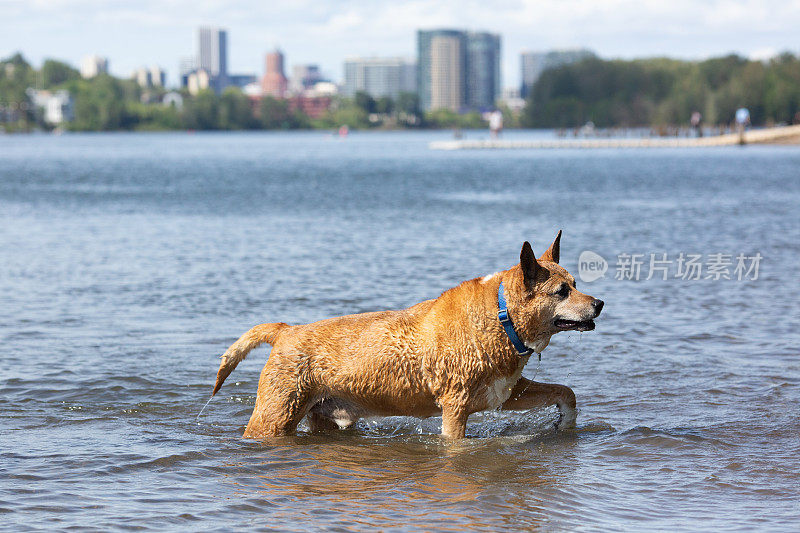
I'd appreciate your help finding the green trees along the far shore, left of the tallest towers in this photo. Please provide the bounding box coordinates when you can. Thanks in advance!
[0,54,483,131]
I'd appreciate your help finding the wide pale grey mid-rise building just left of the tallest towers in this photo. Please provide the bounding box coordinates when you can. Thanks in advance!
[342,57,417,100]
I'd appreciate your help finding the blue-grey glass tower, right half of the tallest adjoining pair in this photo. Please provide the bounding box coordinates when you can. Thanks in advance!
[466,32,500,111]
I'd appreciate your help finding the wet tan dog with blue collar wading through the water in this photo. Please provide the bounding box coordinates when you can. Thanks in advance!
[212,231,603,438]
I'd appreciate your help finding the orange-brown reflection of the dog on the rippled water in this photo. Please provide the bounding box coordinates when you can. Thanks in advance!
[219,435,575,530]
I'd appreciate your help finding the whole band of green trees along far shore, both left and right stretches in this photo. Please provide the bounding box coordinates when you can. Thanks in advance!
[6,53,800,131]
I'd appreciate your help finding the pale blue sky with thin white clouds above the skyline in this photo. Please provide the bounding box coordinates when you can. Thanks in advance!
[0,0,800,87]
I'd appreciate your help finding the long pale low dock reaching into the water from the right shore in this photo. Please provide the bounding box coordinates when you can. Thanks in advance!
[428,124,800,150]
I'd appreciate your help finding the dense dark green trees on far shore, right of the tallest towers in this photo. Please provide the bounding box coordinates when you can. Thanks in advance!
[521,53,800,128]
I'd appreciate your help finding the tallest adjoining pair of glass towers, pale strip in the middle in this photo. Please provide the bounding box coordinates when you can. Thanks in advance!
[417,30,500,111]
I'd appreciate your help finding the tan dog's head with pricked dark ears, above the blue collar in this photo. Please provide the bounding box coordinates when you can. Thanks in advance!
[509,231,603,345]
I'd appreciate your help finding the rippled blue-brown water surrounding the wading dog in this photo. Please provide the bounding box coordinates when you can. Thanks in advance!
[0,132,800,531]
